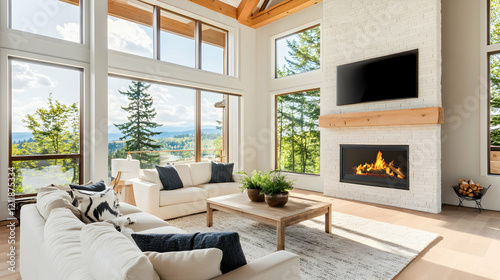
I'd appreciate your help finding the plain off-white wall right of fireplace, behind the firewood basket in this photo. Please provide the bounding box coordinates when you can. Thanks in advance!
[442,0,500,210]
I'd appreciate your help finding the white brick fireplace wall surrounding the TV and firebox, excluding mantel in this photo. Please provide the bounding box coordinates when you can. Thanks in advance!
[321,0,441,213]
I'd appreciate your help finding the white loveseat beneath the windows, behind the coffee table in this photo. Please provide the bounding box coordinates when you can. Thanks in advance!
[129,162,239,219]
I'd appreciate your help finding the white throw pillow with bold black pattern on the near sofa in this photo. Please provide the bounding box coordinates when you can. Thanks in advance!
[73,187,121,223]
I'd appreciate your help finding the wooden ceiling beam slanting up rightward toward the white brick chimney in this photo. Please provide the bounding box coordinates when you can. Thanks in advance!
[248,0,323,29]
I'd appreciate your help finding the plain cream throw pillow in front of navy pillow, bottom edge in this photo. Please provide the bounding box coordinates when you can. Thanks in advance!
[145,248,222,280]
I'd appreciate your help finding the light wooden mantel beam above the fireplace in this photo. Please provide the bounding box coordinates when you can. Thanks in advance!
[319,107,444,128]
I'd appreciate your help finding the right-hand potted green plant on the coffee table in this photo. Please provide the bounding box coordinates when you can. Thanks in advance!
[261,173,295,207]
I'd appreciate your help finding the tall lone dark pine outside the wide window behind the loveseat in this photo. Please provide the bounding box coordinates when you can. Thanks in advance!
[115,81,161,168]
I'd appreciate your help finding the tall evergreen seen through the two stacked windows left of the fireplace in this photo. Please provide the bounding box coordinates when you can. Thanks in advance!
[277,27,320,173]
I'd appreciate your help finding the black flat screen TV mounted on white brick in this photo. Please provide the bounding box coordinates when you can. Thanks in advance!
[337,50,418,105]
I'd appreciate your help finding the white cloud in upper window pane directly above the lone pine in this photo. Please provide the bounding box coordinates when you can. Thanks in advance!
[108,18,153,56]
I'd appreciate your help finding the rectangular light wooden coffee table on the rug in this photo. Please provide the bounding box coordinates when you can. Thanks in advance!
[207,193,332,251]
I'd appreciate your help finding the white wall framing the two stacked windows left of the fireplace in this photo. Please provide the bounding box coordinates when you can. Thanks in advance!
[254,3,323,192]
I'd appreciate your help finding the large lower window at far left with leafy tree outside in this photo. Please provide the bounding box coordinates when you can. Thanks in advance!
[9,58,83,195]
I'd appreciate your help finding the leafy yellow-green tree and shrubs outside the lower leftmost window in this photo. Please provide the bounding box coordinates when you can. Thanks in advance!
[12,94,80,193]
